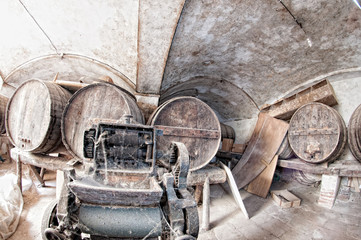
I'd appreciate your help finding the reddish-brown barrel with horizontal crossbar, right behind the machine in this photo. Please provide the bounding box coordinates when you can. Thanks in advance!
[149,97,221,171]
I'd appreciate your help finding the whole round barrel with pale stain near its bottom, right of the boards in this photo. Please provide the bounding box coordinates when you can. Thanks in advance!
[288,103,346,163]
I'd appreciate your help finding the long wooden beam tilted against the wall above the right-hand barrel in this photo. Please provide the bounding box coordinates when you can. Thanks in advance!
[262,79,338,120]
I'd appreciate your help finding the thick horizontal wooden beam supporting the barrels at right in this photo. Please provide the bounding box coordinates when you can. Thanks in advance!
[278,159,361,177]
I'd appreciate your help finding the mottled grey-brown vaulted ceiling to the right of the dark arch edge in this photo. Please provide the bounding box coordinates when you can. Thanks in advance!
[161,0,361,119]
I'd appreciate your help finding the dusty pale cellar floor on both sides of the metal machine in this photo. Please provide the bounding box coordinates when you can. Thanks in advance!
[0,159,361,240]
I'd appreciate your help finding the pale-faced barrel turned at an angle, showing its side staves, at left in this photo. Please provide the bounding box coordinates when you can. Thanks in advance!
[5,79,71,153]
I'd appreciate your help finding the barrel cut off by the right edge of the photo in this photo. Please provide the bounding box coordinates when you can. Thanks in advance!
[348,105,361,162]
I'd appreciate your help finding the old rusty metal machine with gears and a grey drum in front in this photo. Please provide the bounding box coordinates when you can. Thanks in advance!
[45,123,199,239]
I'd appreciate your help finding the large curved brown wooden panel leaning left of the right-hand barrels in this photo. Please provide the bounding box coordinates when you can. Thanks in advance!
[232,113,288,188]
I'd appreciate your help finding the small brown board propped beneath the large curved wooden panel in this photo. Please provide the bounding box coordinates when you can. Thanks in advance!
[247,155,278,198]
